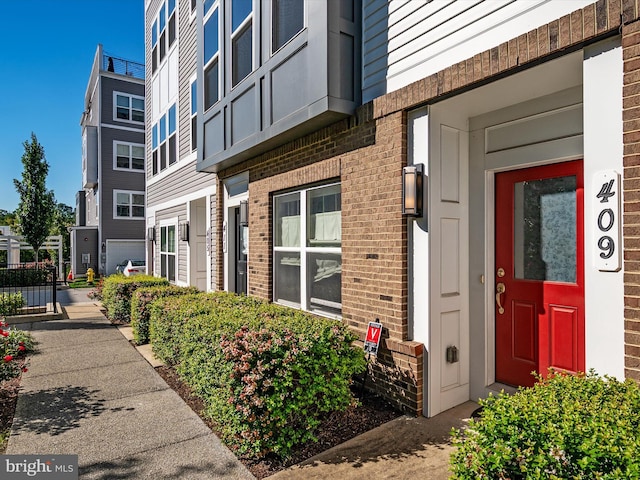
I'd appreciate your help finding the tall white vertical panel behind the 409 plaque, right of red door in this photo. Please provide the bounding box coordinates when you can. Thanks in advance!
[583,37,625,379]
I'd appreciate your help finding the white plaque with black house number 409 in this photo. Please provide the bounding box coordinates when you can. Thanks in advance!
[593,170,621,272]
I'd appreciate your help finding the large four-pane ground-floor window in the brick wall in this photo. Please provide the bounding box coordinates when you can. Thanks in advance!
[273,184,342,316]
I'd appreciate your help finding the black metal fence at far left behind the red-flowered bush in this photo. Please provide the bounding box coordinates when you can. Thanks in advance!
[0,263,58,313]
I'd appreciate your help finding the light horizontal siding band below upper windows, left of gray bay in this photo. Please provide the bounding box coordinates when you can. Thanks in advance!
[147,161,216,207]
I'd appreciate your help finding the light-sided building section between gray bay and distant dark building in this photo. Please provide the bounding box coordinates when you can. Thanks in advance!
[145,0,217,290]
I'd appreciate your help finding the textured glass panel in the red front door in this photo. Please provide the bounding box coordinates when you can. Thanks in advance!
[513,176,576,283]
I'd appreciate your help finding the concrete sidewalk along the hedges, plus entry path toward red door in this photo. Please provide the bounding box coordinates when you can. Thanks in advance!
[6,289,477,480]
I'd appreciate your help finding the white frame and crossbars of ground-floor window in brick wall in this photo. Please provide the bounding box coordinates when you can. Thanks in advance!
[271,182,342,318]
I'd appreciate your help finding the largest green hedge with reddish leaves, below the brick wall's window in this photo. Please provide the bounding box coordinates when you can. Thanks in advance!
[150,292,365,457]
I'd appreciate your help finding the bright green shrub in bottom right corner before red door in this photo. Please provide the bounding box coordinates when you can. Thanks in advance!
[451,371,640,479]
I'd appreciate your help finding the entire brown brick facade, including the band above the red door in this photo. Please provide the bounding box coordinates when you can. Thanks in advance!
[212,0,640,414]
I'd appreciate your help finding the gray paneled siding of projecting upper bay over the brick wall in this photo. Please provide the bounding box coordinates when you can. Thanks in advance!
[198,0,361,172]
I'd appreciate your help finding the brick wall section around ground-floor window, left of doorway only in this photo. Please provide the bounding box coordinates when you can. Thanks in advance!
[218,103,422,414]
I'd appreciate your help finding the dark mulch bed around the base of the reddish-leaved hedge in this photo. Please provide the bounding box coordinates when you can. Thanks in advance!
[156,367,402,479]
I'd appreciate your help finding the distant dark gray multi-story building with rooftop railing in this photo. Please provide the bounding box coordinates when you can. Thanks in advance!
[71,45,145,275]
